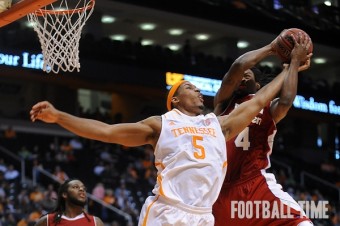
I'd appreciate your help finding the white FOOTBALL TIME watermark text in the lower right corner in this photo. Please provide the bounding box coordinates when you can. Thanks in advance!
[231,200,329,219]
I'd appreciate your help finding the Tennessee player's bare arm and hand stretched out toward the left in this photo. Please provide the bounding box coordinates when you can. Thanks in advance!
[30,101,161,146]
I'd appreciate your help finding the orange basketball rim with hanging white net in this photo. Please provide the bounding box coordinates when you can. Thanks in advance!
[27,0,95,74]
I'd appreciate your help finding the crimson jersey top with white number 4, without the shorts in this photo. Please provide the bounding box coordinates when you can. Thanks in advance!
[223,94,276,184]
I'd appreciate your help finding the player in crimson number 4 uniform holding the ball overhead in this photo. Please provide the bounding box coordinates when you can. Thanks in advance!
[213,31,313,226]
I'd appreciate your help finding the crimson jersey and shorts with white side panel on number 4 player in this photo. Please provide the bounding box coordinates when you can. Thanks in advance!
[213,95,313,226]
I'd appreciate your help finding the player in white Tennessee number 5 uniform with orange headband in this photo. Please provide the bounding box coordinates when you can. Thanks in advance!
[30,44,307,226]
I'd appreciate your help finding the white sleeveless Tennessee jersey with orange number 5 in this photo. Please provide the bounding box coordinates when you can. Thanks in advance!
[153,109,227,207]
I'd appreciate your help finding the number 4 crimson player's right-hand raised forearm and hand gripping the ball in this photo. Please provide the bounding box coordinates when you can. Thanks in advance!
[270,34,312,123]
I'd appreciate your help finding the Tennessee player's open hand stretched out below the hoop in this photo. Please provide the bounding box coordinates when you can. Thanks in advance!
[30,101,59,123]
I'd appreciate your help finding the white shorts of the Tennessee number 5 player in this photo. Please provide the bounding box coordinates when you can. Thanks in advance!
[138,196,215,226]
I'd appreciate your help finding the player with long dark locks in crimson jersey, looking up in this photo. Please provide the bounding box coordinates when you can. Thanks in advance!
[35,179,104,226]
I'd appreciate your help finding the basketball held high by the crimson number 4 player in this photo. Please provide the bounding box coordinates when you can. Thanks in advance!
[273,28,313,63]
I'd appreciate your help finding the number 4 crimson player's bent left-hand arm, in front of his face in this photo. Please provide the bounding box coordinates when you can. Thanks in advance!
[214,44,274,115]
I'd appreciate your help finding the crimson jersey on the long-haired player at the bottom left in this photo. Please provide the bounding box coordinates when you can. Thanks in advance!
[47,213,96,226]
